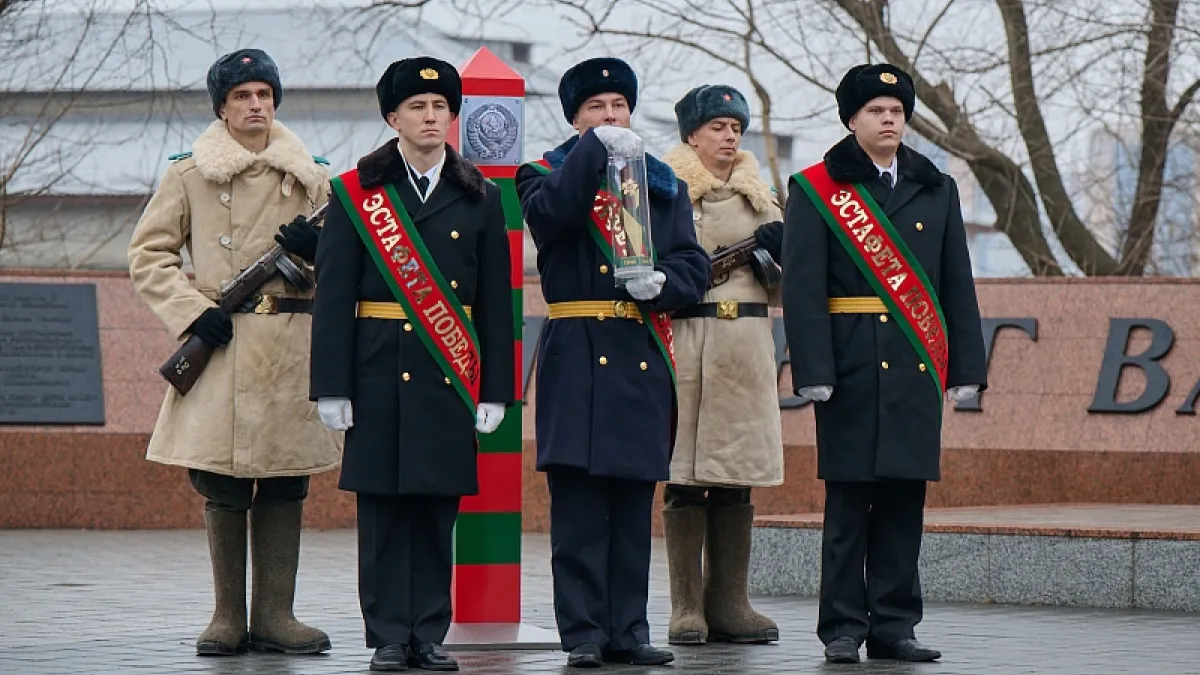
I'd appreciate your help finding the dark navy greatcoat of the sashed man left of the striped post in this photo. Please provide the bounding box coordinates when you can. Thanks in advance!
[310,141,515,496]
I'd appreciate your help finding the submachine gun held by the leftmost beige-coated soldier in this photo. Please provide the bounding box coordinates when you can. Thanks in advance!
[158,202,329,395]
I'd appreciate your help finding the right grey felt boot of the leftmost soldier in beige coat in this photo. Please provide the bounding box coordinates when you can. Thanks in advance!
[250,502,332,653]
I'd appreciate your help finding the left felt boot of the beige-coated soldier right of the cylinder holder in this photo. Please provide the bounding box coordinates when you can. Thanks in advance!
[662,507,708,645]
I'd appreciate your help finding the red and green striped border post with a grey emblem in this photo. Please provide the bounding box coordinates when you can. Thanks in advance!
[448,48,526,629]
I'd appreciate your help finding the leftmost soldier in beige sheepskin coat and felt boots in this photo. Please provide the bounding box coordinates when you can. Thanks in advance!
[128,49,342,656]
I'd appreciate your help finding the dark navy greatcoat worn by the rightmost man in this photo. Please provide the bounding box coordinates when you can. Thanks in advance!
[781,136,986,480]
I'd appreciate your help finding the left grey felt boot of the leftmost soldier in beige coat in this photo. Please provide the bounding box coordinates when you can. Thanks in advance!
[196,509,247,656]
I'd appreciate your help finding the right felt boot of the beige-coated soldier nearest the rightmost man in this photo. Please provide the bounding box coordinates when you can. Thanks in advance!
[704,504,779,644]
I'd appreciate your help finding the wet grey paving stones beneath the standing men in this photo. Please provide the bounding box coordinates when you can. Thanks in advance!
[0,531,1200,675]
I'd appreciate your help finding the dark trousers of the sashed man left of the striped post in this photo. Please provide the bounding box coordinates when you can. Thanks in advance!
[358,495,460,649]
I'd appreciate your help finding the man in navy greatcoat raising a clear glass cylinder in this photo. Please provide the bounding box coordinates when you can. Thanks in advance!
[516,59,712,668]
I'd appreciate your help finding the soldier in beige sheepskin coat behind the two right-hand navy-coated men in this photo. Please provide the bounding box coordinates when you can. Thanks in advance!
[662,85,784,645]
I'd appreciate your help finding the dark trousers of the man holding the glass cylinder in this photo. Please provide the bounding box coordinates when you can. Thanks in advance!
[546,467,655,651]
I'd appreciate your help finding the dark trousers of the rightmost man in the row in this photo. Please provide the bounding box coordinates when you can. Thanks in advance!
[817,480,925,645]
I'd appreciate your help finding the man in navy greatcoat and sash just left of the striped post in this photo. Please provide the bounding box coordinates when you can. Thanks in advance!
[310,56,515,670]
